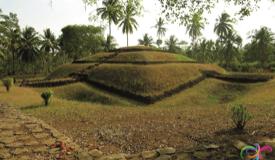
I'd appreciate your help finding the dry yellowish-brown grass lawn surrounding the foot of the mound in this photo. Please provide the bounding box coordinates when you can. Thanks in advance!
[0,79,275,153]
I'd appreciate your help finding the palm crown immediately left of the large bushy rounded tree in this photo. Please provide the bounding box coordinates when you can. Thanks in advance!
[40,28,59,54]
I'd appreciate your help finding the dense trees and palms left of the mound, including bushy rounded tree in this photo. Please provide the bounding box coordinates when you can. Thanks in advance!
[0,10,112,75]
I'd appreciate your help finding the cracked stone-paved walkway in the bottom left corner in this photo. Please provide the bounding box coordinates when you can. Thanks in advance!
[0,104,90,160]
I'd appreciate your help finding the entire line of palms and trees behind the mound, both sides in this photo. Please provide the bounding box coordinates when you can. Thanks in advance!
[0,0,275,75]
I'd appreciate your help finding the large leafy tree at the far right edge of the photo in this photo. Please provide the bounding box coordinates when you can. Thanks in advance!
[246,27,274,66]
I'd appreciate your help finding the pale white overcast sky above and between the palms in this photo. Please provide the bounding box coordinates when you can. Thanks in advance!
[0,0,275,46]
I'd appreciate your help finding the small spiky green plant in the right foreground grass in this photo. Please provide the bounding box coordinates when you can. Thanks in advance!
[231,104,252,131]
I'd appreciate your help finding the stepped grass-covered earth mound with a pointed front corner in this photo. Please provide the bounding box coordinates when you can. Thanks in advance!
[45,46,224,103]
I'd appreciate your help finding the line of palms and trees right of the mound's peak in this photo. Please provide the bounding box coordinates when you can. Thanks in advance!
[139,13,275,71]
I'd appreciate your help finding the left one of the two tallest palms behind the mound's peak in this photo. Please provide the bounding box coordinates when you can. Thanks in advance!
[97,0,123,36]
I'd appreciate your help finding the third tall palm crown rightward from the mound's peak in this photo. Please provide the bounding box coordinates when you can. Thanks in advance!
[214,13,234,41]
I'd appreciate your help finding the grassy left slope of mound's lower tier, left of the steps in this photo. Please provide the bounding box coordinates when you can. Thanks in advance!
[47,63,93,79]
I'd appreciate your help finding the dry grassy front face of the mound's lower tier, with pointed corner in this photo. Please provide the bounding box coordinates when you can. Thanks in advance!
[88,64,223,96]
